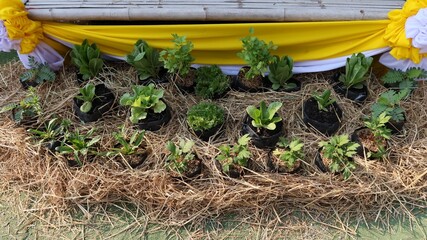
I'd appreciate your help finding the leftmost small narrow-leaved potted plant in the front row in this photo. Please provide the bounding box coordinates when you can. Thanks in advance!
[28,118,71,152]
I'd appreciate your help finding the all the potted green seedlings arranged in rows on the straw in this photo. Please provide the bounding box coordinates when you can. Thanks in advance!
[1,29,426,178]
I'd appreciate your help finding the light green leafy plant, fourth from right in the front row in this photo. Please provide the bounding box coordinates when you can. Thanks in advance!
[216,134,252,173]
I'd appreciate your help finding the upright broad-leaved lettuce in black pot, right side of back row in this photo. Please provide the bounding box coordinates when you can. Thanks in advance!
[333,53,373,103]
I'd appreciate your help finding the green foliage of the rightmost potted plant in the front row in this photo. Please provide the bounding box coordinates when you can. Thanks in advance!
[364,112,391,158]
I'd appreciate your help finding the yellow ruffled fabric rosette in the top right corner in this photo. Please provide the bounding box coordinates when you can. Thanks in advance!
[384,0,427,64]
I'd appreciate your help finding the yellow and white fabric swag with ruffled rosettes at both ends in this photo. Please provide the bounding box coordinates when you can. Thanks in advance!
[0,0,427,74]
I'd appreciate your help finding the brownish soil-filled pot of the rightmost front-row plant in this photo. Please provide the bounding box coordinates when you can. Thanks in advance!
[351,127,387,159]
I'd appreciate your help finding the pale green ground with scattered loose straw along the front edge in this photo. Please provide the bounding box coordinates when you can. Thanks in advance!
[0,50,427,239]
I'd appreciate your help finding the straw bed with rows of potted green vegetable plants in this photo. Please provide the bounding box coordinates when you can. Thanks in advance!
[0,23,427,235]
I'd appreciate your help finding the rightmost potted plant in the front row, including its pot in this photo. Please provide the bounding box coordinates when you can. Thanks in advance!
[351,112,391,159]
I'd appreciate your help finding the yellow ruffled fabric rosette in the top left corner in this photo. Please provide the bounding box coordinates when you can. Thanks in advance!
[0,0,43,54]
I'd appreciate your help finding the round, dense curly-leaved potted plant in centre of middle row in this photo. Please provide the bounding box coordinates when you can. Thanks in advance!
[187,102,225,141]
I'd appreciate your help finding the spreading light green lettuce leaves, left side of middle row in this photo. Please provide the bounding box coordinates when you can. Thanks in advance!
[120,83,166,123]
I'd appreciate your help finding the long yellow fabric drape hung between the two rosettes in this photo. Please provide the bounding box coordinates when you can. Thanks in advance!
[43,20,390,65]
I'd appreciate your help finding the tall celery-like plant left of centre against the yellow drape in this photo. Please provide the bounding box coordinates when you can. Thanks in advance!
[160,34,194,76]
